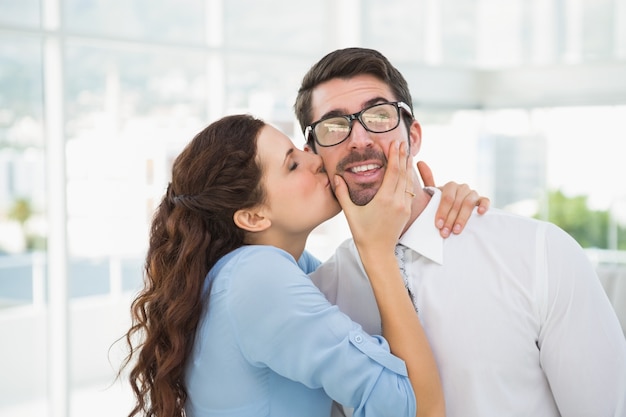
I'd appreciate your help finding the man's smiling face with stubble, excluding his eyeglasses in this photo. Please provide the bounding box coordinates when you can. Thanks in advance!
[311,75,421,205]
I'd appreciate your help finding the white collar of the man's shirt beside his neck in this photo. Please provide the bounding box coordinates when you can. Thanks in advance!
[400,187,443,265]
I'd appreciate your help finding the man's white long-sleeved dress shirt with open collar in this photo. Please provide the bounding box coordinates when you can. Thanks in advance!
[311,189,626,417]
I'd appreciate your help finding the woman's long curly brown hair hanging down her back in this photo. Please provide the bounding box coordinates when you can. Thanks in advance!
[120,115,265,417]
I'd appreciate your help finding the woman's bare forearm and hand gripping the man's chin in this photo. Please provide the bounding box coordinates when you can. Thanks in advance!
[335,143,445,417]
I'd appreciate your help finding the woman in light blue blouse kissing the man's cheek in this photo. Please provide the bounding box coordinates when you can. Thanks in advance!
[119,115,476,417]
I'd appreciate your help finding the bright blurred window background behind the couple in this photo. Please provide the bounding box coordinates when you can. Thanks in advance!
[0,0,626,417]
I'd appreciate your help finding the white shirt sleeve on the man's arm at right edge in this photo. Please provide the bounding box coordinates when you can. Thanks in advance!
[538,225,626,417]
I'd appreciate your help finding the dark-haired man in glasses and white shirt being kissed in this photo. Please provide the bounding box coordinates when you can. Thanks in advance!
[295,48,626,417]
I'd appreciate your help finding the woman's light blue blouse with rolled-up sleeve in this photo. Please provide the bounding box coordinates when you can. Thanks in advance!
[186,246,416,417]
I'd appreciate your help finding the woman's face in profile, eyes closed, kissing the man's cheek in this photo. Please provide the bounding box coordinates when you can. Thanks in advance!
[257,125,341,234]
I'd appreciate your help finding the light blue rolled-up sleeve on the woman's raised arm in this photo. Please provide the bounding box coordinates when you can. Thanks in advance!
[223,247,416,416]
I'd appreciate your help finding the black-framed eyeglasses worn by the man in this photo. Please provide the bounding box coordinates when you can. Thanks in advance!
[304,101,413,147]
